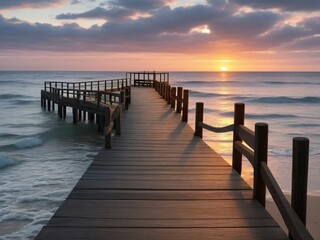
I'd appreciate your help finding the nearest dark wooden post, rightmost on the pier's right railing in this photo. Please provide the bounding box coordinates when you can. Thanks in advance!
[291,137,309,225]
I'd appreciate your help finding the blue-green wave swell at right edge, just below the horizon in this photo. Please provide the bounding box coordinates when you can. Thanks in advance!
[249,96,320,104]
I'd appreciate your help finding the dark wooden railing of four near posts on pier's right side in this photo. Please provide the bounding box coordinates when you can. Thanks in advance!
[194,102,313,240]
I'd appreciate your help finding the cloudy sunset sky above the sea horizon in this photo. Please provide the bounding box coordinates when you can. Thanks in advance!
[0,0,320,71]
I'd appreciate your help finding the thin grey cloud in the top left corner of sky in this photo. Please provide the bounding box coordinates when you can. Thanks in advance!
[0,0,66,9]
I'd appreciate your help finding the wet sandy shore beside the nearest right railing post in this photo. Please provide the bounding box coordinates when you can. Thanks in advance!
[266,195,320,239]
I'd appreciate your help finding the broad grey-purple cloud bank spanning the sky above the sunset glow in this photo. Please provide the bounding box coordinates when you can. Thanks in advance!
[0,0,320,53]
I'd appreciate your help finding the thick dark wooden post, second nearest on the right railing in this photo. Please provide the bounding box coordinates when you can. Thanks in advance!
[253,123,268,207]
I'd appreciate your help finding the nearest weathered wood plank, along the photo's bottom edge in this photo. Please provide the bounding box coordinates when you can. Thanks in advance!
[37,227,288,240]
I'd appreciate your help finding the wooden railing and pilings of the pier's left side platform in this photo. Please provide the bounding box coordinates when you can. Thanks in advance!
[41,78,131,148]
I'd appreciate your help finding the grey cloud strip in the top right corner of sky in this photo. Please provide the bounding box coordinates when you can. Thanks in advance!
[229,0,320,11]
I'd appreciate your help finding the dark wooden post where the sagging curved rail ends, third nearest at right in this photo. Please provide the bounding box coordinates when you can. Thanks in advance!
[232,103,245,175]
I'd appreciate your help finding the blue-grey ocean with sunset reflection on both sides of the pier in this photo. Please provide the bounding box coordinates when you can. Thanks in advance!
[0,71,320,239]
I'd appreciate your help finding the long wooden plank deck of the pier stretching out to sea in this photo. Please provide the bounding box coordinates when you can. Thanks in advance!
[36,72,312,240]
